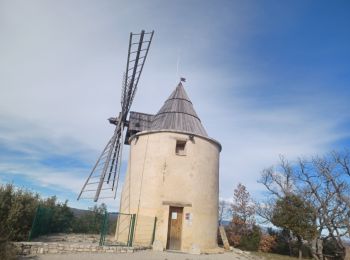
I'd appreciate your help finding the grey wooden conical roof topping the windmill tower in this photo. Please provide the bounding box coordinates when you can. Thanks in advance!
[151,82,208,137]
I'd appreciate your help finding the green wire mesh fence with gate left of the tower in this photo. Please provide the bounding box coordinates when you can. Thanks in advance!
[29,206,157,247]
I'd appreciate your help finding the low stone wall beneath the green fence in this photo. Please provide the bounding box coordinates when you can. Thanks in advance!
[14,242,147,255]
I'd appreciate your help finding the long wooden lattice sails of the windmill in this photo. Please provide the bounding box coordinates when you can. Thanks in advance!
[78,30,154,202]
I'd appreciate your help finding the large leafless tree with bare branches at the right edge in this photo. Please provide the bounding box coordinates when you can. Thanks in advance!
[257,150,350,259]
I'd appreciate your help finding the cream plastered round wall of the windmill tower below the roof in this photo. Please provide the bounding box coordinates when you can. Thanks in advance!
[121,132,220,251]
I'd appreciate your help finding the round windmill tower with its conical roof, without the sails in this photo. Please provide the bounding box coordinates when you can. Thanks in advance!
[120,82,221,251]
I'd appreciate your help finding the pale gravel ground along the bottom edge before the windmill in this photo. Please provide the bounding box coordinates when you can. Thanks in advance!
[20,251,258,260]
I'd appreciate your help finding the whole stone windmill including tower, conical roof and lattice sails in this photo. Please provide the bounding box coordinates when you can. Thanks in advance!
[78,31,221,252]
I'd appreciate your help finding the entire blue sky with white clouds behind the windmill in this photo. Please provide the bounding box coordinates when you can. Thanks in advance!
[0,0,350,210]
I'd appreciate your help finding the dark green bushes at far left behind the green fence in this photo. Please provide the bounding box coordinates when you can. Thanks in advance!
[0,184,106,242]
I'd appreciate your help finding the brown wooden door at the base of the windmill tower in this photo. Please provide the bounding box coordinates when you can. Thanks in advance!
[167,207,183,250]
